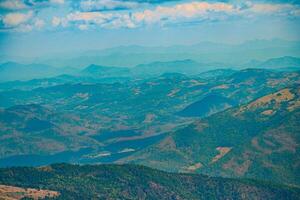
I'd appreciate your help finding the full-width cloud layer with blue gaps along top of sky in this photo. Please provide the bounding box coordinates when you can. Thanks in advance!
[0,0,300,31]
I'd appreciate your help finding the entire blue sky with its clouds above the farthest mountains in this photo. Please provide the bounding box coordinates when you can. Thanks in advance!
[0,0,300,57]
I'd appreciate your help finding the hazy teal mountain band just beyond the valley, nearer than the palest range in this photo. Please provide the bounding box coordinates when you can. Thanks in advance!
[0,56,300,82]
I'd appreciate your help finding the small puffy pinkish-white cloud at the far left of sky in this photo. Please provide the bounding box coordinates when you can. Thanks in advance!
[2,11,33,27]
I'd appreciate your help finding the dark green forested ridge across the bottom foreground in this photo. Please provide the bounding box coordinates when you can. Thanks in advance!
[0,164,300,200]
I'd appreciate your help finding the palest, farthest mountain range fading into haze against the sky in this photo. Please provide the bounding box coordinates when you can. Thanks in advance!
[0,39,300,68]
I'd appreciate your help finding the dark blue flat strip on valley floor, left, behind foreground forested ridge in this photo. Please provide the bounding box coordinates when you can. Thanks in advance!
[0,132,165,167]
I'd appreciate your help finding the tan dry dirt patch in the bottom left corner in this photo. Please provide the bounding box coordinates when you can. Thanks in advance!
[0,185,59,200]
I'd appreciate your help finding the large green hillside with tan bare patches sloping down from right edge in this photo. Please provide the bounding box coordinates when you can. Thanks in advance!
[123,85,300,185]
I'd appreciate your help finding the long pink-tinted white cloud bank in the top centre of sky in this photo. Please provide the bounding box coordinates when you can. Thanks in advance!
[52,0,235,29]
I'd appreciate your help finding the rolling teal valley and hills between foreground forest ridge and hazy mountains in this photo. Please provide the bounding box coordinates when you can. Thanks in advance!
[0,61,300,189]
